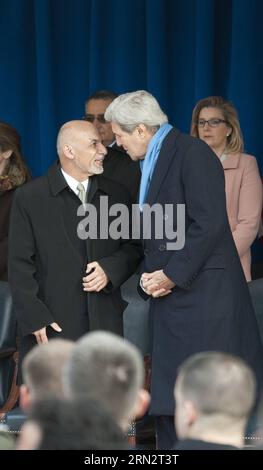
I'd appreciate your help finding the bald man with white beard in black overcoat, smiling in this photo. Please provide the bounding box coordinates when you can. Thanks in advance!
[9,121,141,381]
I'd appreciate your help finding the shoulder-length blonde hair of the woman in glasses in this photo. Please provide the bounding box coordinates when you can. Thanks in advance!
[191,96,244,153]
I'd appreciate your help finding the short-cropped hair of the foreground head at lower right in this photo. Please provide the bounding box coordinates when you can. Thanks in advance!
[175,352,256,420]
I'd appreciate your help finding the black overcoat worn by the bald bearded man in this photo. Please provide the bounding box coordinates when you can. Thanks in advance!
[9,163,141,370]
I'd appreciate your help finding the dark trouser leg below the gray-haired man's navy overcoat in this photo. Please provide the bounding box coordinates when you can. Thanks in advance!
[155,416,177,450]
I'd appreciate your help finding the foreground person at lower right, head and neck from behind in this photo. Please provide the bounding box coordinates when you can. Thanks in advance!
[174,352,256,450]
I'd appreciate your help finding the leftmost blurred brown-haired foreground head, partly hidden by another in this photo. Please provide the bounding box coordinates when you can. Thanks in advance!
[22,339,74,401]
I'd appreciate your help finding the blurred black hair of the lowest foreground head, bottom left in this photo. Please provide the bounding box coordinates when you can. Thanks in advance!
[29,399,128,450]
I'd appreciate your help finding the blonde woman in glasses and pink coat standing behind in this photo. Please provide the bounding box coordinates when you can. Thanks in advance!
[191,96,262,281]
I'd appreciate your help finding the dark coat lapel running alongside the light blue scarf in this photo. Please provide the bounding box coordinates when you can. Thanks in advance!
[145,128,180,205]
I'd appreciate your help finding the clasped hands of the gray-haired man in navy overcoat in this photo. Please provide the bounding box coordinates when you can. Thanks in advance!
[141,269,175,297]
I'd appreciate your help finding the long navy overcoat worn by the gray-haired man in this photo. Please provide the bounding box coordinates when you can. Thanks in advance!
[141,129,263,416]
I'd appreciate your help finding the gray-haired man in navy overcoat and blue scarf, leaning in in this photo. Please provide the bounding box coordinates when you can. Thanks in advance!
[105,91,263,449]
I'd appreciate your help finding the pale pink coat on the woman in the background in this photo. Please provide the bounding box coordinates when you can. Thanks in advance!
[222,153,262,281]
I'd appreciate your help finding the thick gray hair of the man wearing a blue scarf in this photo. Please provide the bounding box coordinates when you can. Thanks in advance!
[104,90,168,133]
